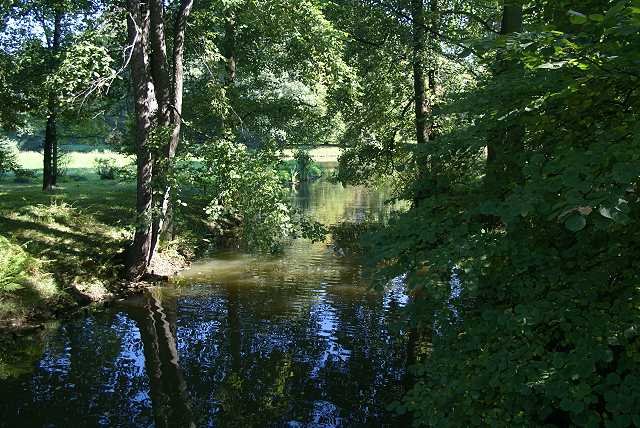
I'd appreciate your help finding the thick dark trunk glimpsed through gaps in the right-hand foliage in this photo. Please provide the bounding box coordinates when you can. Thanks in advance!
[485,0,524,198]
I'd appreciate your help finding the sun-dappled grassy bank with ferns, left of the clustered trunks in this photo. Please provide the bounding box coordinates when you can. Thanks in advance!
[0,176,135,327]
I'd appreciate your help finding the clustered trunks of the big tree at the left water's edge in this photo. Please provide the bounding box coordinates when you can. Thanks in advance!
[127,0,193,278]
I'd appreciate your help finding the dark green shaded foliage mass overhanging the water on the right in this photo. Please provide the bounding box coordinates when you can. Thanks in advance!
[342,1,640,426]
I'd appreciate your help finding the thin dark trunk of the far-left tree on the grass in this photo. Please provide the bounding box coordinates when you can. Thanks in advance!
[42,10,62,192]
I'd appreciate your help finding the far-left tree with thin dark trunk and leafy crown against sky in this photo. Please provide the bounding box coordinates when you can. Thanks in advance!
[0,0,99,191]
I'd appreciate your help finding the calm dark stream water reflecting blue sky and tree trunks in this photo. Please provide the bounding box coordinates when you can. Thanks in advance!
[0,183,406,427]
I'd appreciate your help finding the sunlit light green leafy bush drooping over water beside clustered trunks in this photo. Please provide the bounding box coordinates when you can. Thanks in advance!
[184,140,322,252]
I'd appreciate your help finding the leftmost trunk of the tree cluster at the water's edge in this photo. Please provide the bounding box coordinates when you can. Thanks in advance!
[127,0,158,279]
